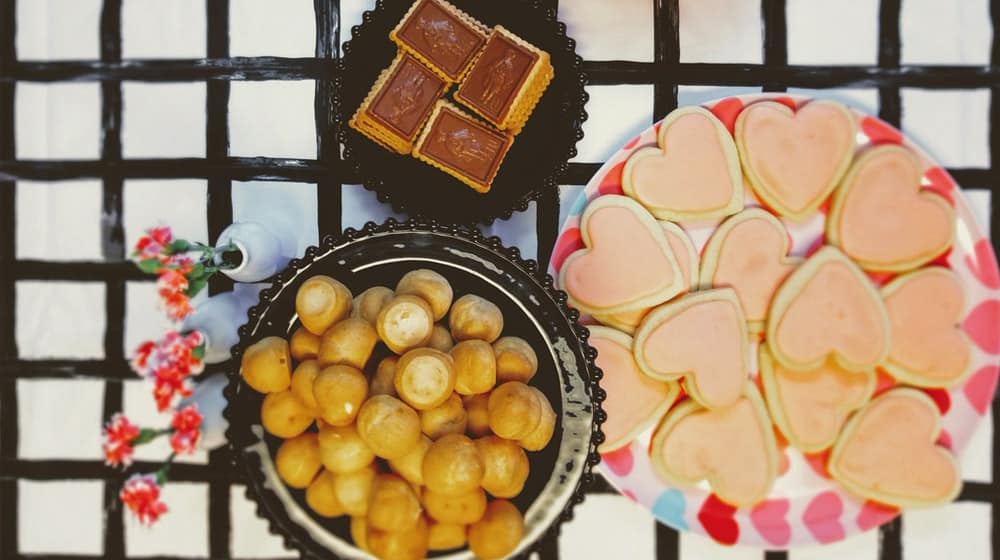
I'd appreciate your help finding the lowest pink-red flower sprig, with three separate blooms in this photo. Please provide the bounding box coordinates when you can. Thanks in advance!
[102,404,204,525]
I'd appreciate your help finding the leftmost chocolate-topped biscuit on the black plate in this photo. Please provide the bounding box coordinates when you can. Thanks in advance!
[349,53,448,153]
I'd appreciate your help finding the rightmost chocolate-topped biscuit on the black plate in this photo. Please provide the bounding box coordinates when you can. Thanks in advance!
[455,26,553,133]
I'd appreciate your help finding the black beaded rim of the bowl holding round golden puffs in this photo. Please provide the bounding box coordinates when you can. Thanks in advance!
[222,218,607,558]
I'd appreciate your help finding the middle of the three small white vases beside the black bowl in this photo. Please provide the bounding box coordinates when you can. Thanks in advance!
[181,284,262,364]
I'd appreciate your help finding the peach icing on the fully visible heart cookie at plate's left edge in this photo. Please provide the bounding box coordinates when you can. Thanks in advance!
[565,206,674,307]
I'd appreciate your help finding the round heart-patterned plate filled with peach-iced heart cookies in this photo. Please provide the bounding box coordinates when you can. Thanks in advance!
[550,94,1000,549]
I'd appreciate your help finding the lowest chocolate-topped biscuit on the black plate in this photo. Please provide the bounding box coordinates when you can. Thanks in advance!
[413,101,513,192]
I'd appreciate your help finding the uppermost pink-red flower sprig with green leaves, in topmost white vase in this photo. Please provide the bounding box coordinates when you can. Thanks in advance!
[132,226,237,321]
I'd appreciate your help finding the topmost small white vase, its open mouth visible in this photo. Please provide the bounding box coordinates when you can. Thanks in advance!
[215,222,292,282]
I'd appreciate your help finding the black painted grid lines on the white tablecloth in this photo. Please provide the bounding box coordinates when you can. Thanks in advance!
[0,0,1000,560]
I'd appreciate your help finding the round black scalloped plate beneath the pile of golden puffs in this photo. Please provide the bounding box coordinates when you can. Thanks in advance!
[225,220,604,559]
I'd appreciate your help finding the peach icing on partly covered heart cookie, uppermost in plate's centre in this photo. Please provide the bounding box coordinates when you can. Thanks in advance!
[712,218,797,321]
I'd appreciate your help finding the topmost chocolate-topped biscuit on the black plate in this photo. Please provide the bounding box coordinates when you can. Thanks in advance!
[389,0,486,82]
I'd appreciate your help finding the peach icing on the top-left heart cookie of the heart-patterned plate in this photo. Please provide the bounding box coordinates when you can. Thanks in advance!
[631,113,733,212]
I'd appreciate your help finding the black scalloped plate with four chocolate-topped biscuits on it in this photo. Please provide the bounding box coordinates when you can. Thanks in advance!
[342,0,587,223]
